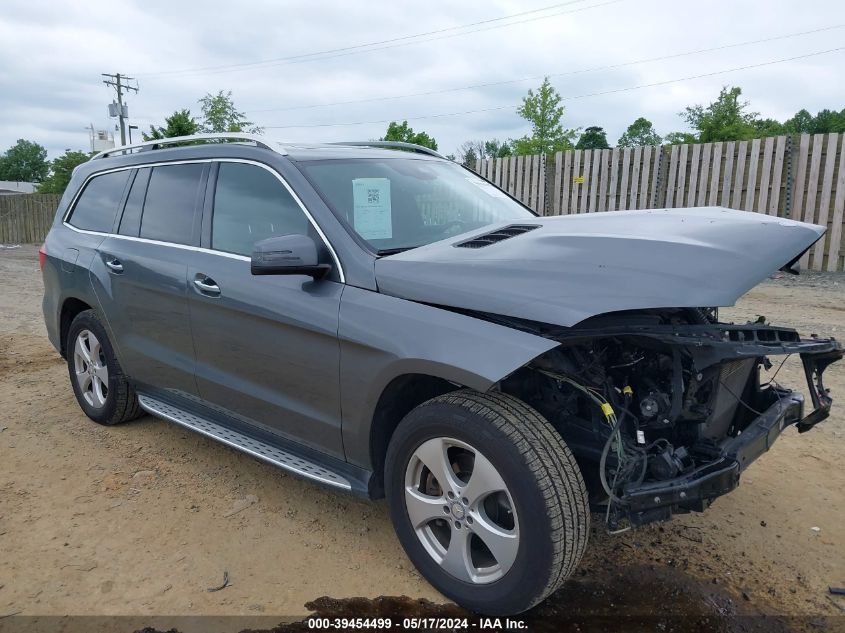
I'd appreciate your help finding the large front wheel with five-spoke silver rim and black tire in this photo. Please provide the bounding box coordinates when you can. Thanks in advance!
[385,390,589,615]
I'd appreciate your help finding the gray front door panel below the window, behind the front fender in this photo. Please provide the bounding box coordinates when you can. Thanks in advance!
[188,252,344,457]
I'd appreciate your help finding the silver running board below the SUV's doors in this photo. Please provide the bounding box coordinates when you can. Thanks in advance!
[138,394,352,490]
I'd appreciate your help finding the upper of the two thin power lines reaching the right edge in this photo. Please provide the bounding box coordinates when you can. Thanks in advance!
[249,24,845,113]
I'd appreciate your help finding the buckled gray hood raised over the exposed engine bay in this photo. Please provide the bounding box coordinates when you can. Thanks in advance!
[375,207,825,326]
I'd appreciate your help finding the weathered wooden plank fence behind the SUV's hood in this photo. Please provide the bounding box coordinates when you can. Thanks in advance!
[475,134,845,271]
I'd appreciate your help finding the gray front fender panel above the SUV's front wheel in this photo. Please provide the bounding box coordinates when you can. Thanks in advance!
[338,287,558,468]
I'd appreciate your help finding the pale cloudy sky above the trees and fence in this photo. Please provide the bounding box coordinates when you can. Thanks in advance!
[0,0,845,158]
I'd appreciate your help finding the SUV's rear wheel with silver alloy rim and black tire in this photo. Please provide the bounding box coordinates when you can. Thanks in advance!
[65,310,143,426]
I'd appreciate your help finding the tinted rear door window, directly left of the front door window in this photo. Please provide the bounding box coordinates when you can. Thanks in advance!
[141,163,205,244]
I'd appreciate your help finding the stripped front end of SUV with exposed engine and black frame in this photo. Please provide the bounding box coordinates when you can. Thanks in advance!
[501,308,843,530]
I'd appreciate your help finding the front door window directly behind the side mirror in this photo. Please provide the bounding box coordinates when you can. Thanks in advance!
[211,163,310,255]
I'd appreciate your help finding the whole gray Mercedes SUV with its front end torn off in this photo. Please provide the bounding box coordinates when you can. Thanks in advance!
[41,134,842,614]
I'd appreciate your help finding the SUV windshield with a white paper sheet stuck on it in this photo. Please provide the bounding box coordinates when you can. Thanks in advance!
[298,158,534,255]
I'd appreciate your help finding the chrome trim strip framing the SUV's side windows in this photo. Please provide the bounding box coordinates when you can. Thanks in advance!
[62,158,346,283]
